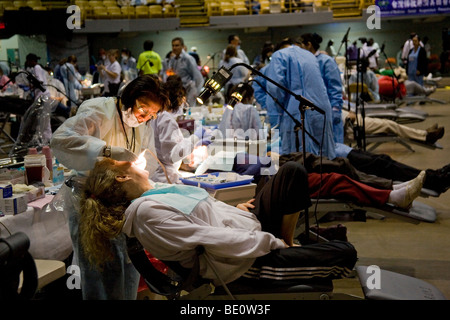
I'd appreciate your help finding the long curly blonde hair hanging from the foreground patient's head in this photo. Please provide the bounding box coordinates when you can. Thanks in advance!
[80,158,130,270]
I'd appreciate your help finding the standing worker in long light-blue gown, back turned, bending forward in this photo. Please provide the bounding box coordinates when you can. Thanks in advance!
[266,41,335,159]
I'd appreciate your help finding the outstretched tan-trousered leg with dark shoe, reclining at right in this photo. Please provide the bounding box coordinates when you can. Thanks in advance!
[342,110,445,144]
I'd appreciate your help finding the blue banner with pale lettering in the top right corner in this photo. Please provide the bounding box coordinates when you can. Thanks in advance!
[375,0,450,17]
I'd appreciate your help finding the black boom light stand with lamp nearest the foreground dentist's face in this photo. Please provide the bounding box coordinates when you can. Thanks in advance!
[197,63,326,242]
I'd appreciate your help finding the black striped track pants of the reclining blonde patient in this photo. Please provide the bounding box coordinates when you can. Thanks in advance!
[242,162,356,285]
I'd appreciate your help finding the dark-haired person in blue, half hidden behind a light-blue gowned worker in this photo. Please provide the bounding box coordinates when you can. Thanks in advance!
[301,33,344,143]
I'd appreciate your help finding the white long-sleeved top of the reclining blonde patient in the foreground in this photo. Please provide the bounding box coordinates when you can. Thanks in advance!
[122,197,285,284]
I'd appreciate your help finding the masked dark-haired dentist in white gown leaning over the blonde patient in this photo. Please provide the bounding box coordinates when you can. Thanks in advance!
[50,75,168,300]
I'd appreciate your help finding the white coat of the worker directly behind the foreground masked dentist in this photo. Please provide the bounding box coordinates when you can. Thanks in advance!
[150,111,194,183]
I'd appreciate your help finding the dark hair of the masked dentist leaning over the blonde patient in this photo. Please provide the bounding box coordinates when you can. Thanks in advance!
[120,74,170,110]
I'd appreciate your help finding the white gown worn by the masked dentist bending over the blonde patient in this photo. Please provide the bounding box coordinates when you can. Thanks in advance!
[51,97,157,175]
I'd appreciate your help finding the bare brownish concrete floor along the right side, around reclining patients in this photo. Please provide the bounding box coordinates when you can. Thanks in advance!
[328,82,450,299]
